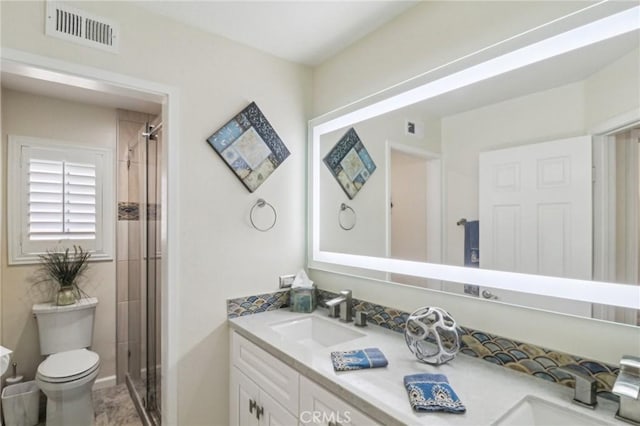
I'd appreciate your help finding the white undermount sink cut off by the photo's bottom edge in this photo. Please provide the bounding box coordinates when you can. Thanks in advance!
[492,395,606,426]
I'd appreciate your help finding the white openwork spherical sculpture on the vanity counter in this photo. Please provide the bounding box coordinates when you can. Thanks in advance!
[404,307,460,365]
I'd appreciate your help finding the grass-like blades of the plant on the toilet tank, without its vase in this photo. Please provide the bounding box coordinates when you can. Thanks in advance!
[38,246,91,294]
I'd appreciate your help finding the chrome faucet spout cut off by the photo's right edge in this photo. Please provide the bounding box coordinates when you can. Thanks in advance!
[612,355,640,425]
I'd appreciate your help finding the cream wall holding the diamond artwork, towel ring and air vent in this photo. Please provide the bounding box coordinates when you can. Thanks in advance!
[1,1,311,426]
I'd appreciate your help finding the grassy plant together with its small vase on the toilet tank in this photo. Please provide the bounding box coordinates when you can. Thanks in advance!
[38,246,91,306]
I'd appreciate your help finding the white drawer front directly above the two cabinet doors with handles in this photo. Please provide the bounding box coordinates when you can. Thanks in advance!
[231,332,298,413]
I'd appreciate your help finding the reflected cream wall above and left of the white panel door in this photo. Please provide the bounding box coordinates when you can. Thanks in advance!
[442,83,585,265]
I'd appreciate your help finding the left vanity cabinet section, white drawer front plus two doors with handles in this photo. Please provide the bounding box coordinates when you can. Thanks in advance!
[229,332,299,426]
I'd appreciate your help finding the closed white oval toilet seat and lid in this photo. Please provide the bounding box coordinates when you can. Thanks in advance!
[37,349,100,383]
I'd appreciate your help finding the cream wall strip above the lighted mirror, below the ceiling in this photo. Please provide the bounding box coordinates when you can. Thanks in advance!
[313,0,593,117]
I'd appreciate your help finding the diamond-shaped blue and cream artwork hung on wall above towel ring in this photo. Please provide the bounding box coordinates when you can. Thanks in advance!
[207,102,290,192]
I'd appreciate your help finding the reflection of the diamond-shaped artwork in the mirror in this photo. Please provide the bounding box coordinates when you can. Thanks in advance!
[323,127,376,200]
